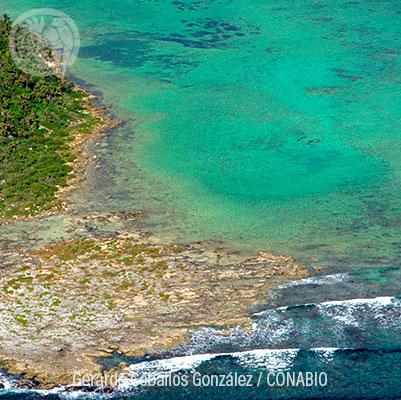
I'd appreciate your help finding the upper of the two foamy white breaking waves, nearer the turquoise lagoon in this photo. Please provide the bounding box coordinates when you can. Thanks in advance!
[182,296,401,354]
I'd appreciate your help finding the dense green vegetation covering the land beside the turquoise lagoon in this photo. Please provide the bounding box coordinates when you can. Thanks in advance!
[0,15,98,217]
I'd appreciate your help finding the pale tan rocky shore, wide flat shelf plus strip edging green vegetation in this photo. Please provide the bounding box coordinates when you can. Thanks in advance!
[0,63,308,390]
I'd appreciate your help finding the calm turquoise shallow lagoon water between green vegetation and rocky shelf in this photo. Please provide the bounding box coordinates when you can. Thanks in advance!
[6,0,401,261]
